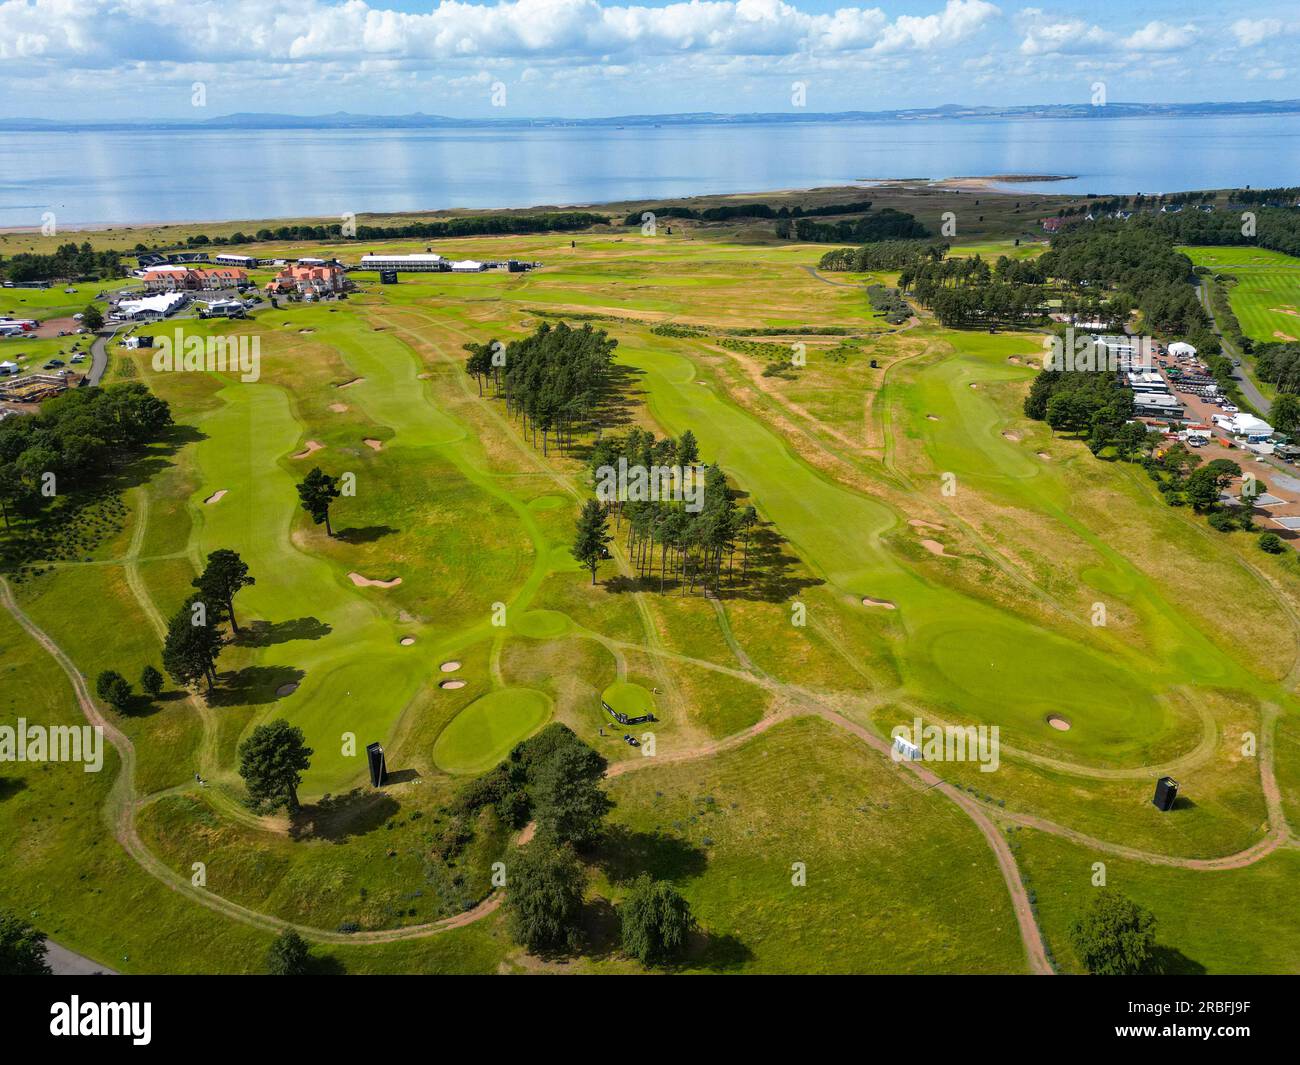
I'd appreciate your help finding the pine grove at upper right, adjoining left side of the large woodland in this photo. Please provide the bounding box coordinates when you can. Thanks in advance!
[898,255,1048,325]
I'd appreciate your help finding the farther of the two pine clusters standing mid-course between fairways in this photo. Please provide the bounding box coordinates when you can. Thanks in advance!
[465,321,619,454]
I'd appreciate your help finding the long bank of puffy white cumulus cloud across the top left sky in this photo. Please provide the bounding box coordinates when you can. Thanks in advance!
[0,0,1000,64]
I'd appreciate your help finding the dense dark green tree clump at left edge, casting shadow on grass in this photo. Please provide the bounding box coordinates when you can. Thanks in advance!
[0,384,172,525]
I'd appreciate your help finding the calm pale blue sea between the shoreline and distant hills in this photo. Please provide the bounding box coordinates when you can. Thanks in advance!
[0,116,1300,226]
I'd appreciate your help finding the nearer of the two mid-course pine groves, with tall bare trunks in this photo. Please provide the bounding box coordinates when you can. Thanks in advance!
[573,429,758,596]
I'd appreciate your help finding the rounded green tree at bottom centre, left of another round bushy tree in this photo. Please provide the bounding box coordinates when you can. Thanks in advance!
[506,839,586,953]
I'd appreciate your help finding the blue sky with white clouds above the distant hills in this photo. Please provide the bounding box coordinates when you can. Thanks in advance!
[0,0,1300,120]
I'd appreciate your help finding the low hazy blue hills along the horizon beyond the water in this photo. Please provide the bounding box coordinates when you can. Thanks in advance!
[0,100,1300,133]
